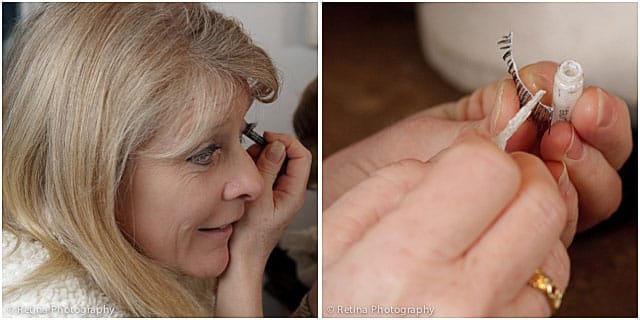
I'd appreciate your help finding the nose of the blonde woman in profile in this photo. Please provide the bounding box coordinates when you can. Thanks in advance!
[222,146,264,201]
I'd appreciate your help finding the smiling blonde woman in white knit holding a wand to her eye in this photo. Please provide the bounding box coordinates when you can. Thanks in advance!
[3,3,311,317]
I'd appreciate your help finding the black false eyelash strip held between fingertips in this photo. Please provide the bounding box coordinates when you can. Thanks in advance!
[498,32,553,133]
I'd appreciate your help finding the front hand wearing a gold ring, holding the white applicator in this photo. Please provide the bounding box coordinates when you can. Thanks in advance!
[322,134,577,317]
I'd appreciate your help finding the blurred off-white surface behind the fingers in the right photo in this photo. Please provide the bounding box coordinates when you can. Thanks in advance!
[417,2,638,123]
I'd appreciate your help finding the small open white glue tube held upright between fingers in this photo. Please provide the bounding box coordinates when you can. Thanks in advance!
[551,60,584,125]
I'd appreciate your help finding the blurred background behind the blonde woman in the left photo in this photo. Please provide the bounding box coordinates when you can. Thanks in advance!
[2,2,318,316]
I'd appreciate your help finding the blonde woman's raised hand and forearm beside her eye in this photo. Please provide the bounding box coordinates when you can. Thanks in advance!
[216,132,311,317]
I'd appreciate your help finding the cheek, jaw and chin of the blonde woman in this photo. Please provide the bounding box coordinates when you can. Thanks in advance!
[119,166,228,276]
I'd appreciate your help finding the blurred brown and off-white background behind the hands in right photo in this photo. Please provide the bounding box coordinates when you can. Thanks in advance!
[322,3,638,318]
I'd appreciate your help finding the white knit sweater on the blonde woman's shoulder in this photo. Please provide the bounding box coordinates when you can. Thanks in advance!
[2,230,129,318]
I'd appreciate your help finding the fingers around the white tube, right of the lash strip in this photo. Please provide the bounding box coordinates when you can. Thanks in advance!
[526,63,633,230]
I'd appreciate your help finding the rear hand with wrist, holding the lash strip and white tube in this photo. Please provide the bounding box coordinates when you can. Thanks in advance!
[323,62,632,229]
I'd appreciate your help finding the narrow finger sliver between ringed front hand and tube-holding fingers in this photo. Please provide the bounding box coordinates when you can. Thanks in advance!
[545,161,578,247]
